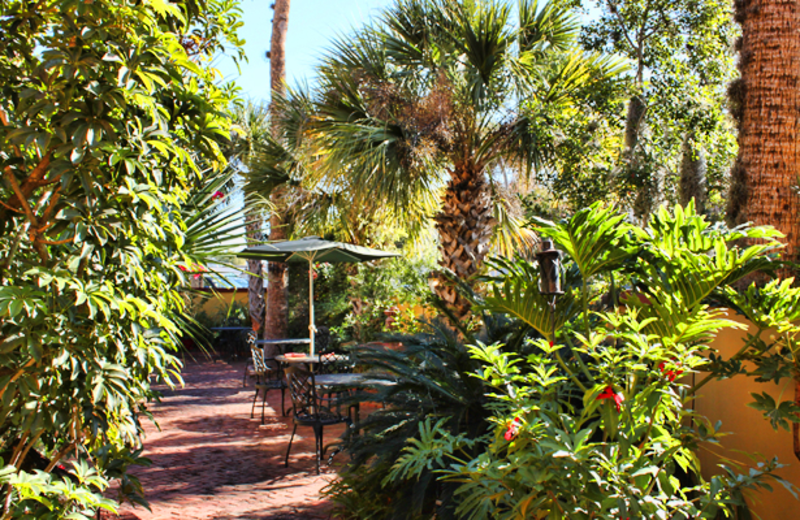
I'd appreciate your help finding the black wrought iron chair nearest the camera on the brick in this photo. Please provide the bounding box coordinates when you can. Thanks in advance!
[284,366,352,475]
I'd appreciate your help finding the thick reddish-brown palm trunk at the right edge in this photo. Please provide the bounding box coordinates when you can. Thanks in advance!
[728,0,800,275]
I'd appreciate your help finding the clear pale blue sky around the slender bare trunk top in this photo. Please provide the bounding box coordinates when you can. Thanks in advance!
[217,0,392,101]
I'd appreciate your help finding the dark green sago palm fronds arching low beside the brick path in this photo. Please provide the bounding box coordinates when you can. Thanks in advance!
[326,305,532,520]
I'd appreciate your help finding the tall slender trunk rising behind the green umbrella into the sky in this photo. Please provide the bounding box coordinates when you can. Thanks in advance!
[265,0,291,354]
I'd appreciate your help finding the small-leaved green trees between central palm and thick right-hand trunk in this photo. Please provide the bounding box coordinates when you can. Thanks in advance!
[582,0,736,220]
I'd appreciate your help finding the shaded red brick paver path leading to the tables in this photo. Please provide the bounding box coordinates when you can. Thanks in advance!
[115,362,343,520]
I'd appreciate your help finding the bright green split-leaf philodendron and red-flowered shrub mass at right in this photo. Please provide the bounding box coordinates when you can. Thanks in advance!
[393,205,800,520]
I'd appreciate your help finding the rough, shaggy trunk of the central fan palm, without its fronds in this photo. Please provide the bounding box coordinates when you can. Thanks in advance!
[434,164,495,319]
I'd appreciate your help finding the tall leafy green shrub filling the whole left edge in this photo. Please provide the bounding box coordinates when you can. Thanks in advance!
[0,0,242,518]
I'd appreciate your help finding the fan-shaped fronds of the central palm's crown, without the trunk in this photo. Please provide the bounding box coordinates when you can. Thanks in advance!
[248,0,624,256]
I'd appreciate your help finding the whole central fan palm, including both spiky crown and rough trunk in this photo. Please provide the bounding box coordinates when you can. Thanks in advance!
[280,0,622,317]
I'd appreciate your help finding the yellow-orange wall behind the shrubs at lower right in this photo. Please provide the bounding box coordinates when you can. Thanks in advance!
[694,313,800,520]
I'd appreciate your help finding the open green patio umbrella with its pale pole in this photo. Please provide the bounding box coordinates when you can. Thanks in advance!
[238,236,400,356]
